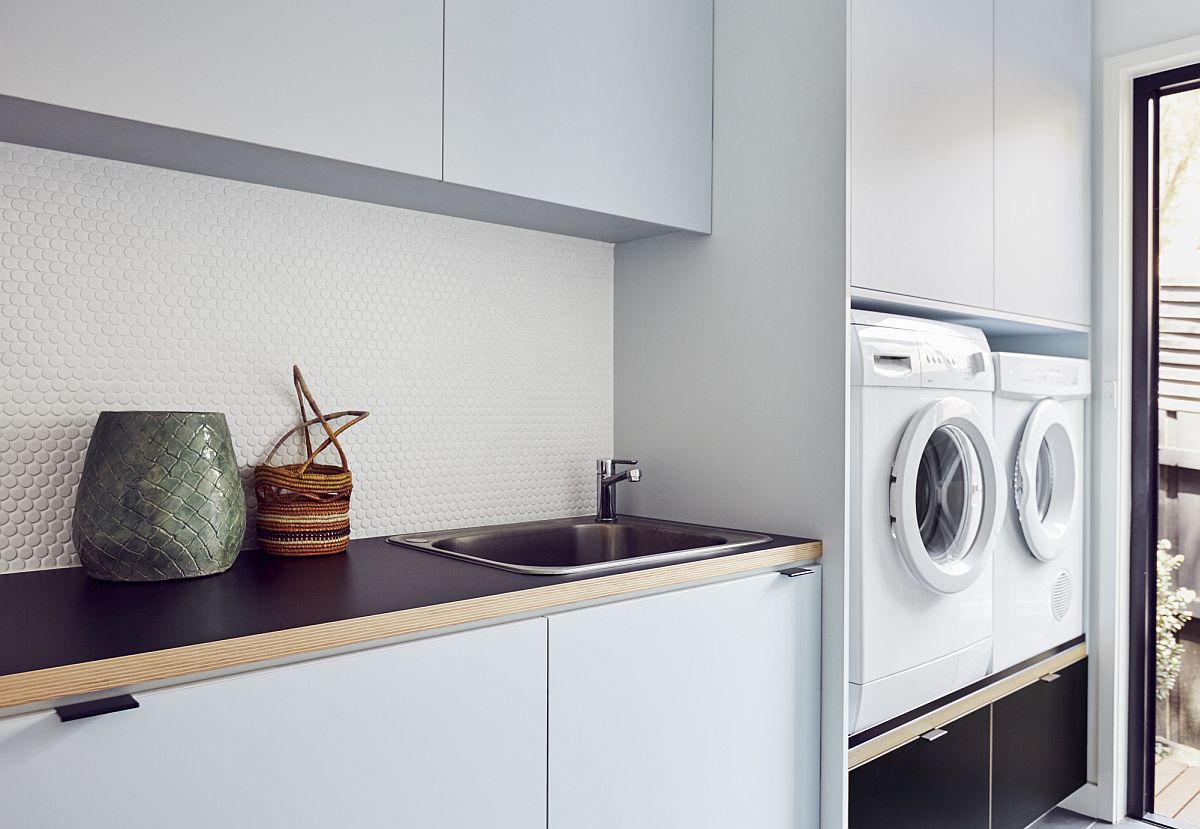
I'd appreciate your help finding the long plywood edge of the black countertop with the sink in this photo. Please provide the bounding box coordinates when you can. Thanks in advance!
[0,541,821,715]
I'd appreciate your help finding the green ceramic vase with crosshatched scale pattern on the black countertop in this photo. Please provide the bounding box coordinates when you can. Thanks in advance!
[71,412,246,582]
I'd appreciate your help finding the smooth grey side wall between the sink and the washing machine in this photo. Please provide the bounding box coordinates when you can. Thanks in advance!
[613,0,847,827]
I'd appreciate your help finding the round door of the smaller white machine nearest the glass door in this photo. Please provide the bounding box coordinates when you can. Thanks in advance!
[1013,400,1080,561]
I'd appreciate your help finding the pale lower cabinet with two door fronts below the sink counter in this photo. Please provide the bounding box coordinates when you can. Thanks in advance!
[0,569,821,829]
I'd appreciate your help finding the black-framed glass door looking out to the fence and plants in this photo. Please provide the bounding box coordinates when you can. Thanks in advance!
[1128,59,1200,827]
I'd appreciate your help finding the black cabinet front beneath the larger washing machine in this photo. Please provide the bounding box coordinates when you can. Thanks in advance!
[850,708,991,829]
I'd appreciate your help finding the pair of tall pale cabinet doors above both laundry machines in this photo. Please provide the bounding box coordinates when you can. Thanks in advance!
[848,0,1092,326]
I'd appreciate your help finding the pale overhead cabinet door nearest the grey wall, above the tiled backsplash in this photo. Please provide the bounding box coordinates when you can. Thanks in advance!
[445,0,713,232]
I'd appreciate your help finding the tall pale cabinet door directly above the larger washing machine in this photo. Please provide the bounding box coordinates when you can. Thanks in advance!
[850,0,994,307]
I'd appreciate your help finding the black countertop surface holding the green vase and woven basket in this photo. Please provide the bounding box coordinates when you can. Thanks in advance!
[0,518,810,677]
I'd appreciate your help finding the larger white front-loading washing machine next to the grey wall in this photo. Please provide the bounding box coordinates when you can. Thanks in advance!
[848,311,1007,733]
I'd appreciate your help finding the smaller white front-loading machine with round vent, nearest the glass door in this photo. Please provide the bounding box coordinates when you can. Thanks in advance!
[992,354,1091,671]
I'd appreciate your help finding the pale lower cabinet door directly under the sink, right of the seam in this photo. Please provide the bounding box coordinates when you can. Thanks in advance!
[550,573,821,829]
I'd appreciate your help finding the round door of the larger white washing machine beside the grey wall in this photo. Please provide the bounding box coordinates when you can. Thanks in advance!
[890,397,1007,593]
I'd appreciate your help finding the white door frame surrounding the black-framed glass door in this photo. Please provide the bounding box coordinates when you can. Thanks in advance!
[1099,36,1200,822]
